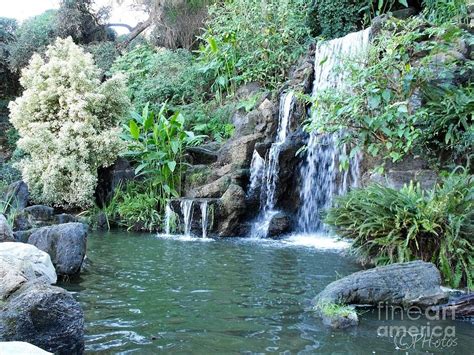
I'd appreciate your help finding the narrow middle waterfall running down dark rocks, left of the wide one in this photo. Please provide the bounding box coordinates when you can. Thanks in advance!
[249,91,295,238]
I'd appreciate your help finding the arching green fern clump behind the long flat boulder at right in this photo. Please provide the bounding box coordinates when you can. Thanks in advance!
[325,172,474,289]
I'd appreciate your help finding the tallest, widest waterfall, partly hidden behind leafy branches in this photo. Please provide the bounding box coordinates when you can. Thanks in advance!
[298,28,370,233]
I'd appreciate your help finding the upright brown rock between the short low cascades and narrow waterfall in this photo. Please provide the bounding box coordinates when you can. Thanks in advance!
[217,184,245,237]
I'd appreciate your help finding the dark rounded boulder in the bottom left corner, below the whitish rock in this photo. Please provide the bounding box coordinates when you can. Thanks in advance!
[0,282,84,354]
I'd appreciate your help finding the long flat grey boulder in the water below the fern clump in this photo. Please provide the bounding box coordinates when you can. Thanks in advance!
[314,261,448,327]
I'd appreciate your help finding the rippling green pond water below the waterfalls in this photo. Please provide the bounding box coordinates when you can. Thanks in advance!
[62,232,474,354]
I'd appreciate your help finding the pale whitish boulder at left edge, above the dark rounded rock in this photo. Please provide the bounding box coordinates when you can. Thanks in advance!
[0,242,57,300]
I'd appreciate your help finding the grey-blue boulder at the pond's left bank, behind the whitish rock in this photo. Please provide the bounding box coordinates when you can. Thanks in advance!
[28,223,87,276]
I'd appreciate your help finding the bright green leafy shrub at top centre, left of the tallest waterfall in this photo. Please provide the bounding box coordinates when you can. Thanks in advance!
[199,0,309,97]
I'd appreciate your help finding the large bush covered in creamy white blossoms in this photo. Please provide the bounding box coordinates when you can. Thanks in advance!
[9,38,128,208]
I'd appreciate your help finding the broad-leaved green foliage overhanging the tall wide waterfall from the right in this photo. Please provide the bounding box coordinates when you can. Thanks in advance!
[309,19,472,170]
